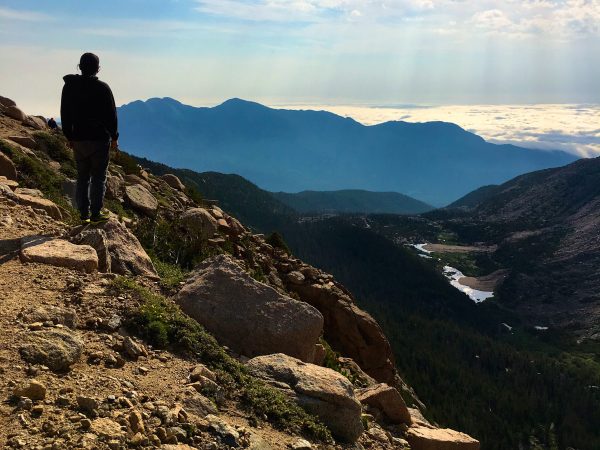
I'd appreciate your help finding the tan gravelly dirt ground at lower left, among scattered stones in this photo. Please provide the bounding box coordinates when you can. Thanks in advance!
[0,196,314,449]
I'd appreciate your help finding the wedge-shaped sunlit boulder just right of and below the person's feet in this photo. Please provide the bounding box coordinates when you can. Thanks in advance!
[103,219,159,279]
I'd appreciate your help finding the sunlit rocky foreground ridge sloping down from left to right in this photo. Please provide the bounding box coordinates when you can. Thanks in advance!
[0,97,478,449]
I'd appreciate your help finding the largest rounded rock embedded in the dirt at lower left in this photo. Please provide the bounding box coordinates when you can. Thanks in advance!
[19,329,83,371]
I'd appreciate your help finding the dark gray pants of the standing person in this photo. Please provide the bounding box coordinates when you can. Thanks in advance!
[73,141,110,218]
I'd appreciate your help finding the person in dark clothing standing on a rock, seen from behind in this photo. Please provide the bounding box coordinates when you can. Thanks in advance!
[60,53,119,223]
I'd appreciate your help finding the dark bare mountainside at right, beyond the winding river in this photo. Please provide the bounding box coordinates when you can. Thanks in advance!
[433,158,600,339]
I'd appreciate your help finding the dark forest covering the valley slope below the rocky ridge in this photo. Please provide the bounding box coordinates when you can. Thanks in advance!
[284,217,600,450]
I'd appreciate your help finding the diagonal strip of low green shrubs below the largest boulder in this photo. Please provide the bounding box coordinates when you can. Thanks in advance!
[112,278,332,442]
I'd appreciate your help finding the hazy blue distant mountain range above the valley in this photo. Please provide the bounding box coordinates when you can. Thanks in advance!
[119,98,576,206]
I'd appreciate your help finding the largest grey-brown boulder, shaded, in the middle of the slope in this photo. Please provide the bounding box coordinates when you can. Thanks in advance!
[175,255,323,361]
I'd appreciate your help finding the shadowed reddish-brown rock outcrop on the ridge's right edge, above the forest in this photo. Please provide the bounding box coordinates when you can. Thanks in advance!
[288,282,396,384]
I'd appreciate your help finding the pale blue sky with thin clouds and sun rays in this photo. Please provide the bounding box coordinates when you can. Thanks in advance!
[0,0,600,155]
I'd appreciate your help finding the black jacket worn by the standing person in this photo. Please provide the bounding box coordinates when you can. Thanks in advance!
[60,75,119,141]
